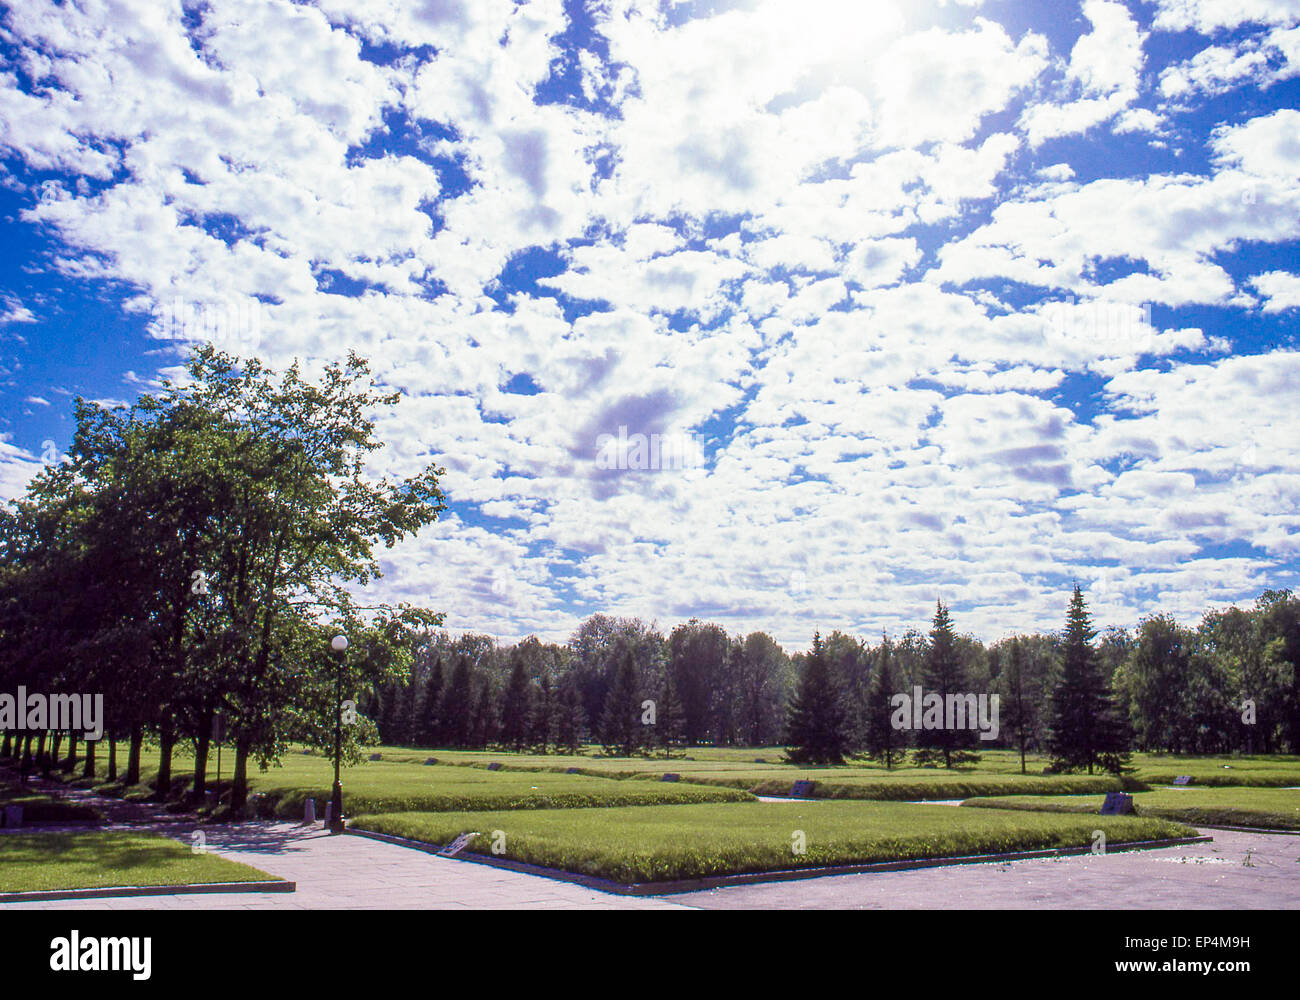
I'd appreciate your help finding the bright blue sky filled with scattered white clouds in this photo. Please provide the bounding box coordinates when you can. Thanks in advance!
[0,0,1300,646]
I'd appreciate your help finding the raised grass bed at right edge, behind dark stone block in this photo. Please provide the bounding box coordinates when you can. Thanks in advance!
[965,787,1300,830]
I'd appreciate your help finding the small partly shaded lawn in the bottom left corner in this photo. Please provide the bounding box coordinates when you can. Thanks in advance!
[0,831,274,892]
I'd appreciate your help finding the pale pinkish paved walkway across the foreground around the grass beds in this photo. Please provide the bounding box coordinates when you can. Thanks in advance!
[0,775,1300,910]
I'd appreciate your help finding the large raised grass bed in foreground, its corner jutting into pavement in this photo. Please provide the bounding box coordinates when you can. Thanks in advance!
[352,802,1192,883]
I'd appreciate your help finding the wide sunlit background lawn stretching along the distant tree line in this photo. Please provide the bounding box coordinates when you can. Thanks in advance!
[27,744,1300,817]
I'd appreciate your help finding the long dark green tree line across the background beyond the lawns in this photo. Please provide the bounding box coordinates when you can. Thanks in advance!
[367,588,1300,770]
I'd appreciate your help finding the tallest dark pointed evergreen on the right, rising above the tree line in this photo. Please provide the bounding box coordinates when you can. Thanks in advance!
[1048,584,1130,774]
